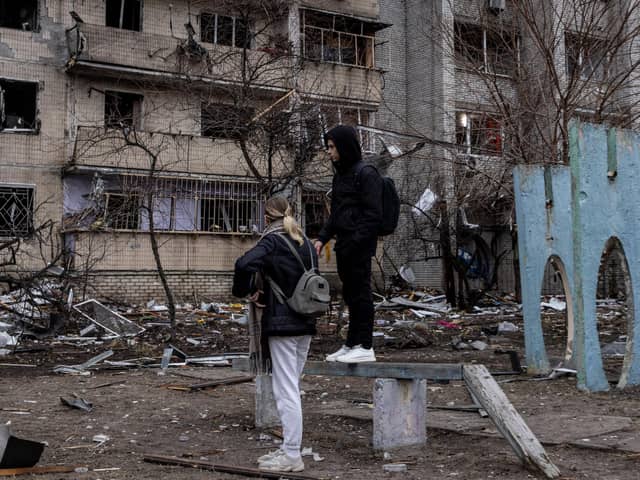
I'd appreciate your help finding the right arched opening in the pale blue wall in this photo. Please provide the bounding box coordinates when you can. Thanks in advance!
[596,237,633,387]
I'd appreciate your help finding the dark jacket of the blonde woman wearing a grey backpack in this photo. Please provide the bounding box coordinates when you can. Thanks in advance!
[232,233,318,336]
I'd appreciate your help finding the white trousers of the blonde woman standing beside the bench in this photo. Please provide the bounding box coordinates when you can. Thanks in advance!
[269,335,311,458]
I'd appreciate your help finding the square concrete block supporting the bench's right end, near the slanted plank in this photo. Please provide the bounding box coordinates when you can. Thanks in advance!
[373,378,427,450]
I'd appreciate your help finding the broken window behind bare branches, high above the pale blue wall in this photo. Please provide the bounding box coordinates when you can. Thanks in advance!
[565,33,608,81]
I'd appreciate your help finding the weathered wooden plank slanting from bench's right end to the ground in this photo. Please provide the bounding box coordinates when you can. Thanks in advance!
[463,365,560,478]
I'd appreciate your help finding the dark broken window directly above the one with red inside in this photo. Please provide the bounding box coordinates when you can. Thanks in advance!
[454,22,519,75]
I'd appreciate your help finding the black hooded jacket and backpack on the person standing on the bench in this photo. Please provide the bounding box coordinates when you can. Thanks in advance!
[318,125,382,257]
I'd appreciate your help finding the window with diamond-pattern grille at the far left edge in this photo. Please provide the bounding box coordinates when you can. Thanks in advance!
[0,185,35,238]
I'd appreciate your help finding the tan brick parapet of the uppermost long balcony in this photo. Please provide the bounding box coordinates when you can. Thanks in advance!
[67,23,382,104]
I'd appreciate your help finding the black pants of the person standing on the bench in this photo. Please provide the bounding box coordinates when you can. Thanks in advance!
[336,251,373,348]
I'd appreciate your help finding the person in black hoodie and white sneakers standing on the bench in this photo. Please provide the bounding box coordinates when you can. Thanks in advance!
[315,125,382,363]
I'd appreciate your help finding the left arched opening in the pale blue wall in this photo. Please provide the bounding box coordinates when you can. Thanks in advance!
[540,255,574,368]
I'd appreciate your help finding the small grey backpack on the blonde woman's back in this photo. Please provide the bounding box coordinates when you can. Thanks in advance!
[268,233,331,315]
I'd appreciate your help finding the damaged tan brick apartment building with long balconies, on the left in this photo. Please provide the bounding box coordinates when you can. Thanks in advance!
[0,0,388,301]
